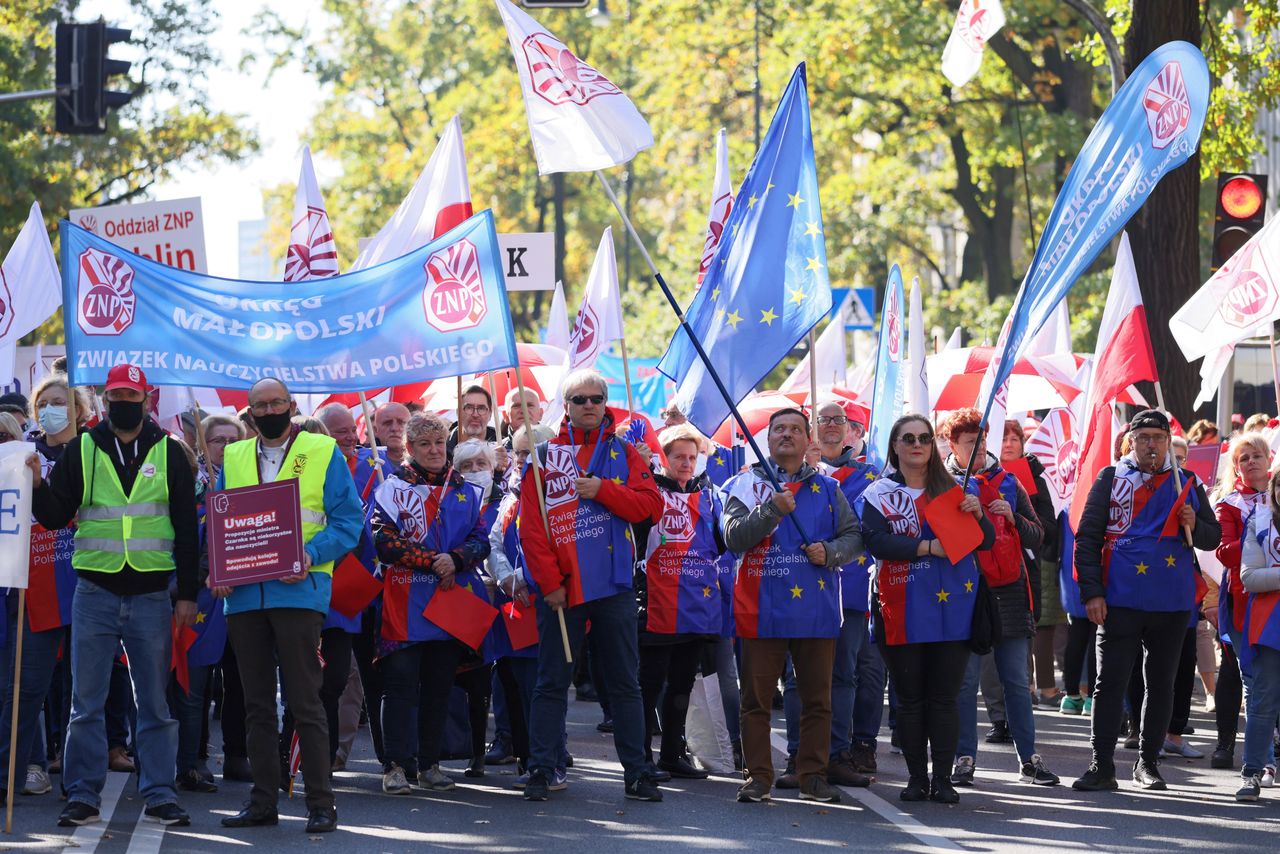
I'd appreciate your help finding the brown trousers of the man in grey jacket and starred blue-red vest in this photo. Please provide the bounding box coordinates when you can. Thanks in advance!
[741,638,836,786]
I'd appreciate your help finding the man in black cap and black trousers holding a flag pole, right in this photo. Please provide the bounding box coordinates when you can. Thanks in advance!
[1073,410,1222,791]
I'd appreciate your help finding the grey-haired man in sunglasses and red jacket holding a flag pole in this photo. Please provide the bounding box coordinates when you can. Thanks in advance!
[520,370,663,800]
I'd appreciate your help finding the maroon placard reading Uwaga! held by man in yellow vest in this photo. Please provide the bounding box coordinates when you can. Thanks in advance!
[212,478,302,588]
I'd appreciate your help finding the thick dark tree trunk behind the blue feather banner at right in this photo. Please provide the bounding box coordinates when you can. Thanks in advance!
[1124,0,1201,424]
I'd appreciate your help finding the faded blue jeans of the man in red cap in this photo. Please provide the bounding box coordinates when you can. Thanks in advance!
[63,579,178,809]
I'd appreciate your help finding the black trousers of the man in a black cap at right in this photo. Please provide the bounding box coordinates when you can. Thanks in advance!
[1091,607,1192,764]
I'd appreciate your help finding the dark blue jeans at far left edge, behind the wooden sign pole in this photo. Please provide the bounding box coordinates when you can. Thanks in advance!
[0,602,67,785]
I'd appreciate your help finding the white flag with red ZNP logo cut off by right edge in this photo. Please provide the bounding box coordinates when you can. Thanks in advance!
[1169,216,1280,361]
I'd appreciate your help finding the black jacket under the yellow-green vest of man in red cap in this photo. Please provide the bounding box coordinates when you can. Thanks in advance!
[31,419,200,602]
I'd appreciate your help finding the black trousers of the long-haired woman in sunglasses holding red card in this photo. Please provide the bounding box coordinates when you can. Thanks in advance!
[881,640,969,778]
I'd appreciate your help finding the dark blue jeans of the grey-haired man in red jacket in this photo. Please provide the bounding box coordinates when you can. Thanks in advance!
[529,590,648,784]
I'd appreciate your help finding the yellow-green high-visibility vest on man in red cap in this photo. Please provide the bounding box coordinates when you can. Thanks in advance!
[72,433,177,572]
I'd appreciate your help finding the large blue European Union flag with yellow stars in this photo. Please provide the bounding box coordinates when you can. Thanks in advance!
[658,63,831,435]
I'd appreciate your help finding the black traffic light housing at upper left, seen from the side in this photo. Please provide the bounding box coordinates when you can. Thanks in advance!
[54,20,133,133]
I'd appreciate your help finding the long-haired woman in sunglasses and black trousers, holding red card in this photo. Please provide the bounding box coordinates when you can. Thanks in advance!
[861,415,996,804]
